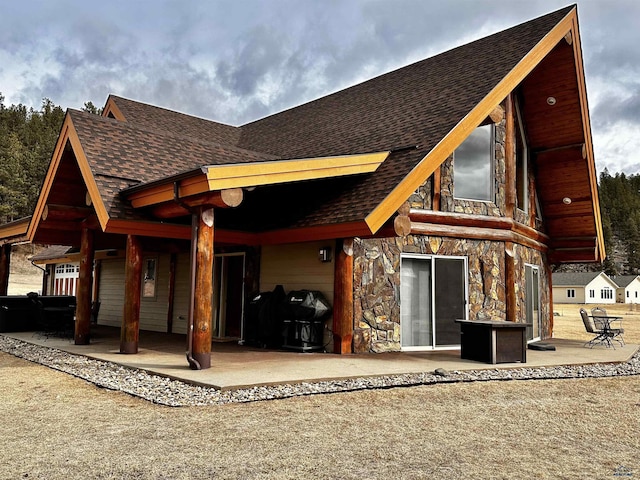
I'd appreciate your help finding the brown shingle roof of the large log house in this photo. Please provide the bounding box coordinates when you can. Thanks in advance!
[71,7,573,230]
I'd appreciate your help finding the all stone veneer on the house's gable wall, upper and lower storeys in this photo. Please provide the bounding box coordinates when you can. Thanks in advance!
[354,107,551,353]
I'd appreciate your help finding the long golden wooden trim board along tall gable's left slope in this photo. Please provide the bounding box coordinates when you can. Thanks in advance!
[365,7,590,236]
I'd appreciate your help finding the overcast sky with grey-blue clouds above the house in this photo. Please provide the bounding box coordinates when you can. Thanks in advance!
[0,0,640,174]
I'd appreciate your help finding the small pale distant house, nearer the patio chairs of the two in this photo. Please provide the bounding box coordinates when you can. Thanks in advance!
[553,272,618,304]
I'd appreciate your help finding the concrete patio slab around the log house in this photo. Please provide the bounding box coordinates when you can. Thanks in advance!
[3,326,638,390]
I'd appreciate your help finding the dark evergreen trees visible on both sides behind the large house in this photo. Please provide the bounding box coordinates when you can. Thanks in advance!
[0,93,640,275]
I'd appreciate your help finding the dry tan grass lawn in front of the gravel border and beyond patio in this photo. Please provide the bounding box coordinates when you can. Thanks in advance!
[0,306,640,479]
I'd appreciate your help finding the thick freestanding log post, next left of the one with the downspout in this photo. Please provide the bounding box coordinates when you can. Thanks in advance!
[120,235,142,354]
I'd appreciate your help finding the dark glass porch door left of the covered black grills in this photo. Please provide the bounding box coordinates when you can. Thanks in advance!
[213,254,244,338]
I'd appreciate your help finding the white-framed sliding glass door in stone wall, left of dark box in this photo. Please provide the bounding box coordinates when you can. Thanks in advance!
[400,256,467,350]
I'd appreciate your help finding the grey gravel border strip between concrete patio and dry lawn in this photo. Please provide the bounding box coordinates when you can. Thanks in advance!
[0,334,640,407]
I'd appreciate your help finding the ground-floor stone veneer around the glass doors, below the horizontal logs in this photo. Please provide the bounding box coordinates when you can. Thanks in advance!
[353,235,550,353]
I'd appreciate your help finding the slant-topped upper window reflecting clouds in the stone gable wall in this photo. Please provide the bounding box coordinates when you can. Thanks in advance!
[453,124,494,201]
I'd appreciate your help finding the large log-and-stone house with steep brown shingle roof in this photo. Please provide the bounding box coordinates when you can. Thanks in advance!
[0,6,605,368]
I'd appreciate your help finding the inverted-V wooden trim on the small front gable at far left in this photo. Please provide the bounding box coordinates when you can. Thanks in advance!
[27,113,109,241]
